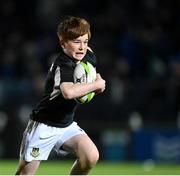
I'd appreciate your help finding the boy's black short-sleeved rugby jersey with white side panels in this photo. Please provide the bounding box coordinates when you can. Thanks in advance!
[30,50,96,127]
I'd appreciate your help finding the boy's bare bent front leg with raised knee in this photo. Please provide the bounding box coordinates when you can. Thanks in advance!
[63,134,99,175]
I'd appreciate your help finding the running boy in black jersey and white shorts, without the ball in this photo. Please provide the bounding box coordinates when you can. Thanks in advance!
[16,16,105,175]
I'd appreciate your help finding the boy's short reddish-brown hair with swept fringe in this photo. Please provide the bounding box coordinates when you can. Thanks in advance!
[57,16,91,41]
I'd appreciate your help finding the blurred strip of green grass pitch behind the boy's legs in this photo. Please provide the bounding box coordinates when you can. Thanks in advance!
[0,160,180,175]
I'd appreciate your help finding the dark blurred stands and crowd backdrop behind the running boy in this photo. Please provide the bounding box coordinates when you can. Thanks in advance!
[0,0,180,161]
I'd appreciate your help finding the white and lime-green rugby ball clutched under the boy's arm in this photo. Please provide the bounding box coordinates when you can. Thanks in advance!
[74,61,96,104]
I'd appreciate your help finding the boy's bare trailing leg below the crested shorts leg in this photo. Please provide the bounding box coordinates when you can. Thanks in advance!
[15,160,40,175]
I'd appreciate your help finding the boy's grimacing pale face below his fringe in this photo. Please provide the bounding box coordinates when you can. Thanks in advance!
[62,34,88,61]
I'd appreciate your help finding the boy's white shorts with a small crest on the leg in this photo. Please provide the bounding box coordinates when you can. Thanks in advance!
[20,120,86,162]
